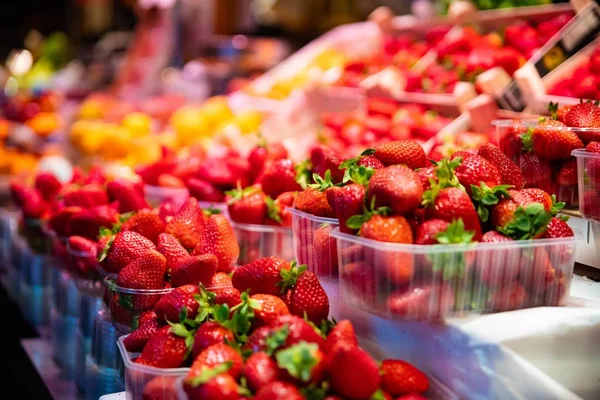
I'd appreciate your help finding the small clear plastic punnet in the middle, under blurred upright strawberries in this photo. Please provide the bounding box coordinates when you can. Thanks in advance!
[231,222,294,265]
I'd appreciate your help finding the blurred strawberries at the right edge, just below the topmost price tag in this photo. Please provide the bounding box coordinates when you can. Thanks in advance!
[548,47,600,100]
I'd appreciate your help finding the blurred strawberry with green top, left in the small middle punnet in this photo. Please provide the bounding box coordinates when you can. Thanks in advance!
[226,186,267,225]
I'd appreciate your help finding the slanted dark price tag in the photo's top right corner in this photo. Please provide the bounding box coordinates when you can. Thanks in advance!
[535,3,600,77]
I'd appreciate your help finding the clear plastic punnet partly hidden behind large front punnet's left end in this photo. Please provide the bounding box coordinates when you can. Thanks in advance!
[288,208,339,281]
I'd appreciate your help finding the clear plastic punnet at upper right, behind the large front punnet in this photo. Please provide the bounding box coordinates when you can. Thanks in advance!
[492,120,600,207]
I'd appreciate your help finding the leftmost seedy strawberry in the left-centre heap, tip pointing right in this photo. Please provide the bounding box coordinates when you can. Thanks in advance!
[98,231,156,272]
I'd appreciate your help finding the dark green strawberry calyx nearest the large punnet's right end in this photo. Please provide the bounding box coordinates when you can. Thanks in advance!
[497,203,552,240]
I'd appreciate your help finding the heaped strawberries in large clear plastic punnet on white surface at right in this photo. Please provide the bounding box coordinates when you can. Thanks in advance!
[294,141,574,318]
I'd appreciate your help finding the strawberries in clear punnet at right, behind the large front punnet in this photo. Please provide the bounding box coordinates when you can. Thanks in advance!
[499,101,600,206]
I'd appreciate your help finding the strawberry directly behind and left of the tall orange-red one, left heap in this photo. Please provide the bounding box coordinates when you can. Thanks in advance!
[165,198,204,249]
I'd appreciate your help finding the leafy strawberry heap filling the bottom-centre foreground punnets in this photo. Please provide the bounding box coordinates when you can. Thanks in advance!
[123,257,429,400]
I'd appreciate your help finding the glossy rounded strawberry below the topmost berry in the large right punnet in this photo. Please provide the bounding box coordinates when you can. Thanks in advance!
[367,165,423,214]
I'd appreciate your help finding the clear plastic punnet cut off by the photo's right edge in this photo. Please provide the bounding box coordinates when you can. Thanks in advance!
[571,149,600,222]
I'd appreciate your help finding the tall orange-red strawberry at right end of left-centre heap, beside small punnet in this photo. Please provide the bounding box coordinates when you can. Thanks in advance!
[192,214,240,272]
